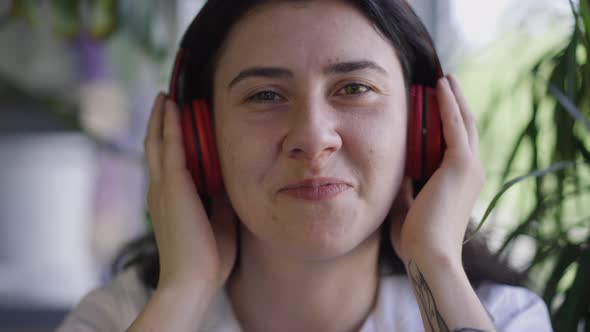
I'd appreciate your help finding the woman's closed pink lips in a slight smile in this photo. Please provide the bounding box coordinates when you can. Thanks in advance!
[279,178,352,201]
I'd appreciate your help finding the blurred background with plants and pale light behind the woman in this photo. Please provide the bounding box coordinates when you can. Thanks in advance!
[0,0,590,331]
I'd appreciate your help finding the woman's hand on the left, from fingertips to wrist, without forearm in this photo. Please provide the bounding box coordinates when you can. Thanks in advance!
[144,94,236,292]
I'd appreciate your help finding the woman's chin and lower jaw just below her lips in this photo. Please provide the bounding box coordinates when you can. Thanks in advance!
[242,197,384,261]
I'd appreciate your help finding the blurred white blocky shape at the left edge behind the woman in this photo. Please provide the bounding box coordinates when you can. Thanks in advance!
[0,134,98,308]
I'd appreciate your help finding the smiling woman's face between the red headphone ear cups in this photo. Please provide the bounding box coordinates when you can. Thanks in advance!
[214,1,407,259]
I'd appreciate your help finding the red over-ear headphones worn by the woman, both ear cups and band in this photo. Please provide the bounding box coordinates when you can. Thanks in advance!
[169,0,445,195]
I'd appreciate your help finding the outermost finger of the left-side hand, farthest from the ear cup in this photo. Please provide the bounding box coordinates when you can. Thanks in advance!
[143,93,165,181]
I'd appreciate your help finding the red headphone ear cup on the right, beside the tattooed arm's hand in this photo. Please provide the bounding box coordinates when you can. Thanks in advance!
[406,85,445,183]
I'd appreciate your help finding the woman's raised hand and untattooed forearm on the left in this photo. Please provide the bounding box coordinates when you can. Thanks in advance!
[128,94,236,332]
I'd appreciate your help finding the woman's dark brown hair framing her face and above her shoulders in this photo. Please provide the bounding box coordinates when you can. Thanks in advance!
[113,0,524,289]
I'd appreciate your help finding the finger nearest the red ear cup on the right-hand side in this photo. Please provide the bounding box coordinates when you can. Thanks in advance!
[436,77,470,151]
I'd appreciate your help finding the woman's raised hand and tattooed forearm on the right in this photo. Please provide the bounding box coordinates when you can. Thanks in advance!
[390,77,495,332]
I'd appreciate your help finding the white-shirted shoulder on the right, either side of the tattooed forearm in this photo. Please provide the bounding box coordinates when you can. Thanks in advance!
[374,275,552,332]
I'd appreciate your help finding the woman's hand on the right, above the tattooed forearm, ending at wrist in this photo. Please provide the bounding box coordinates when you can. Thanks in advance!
[390,76,485,266]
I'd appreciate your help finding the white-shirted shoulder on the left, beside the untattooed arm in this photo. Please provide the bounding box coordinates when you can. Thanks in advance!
[57,268,149,332]
